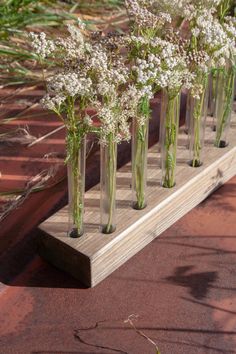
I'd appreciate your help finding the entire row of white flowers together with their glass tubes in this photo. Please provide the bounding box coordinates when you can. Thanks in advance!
[30,0,236,237]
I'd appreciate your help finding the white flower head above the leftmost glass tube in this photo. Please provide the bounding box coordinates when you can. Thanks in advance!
[34,24,93,113]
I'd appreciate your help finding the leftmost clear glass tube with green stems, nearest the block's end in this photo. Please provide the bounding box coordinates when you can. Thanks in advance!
[67,137,86,238]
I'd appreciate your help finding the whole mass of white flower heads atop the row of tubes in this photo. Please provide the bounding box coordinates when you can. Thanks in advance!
[30,0,236,144]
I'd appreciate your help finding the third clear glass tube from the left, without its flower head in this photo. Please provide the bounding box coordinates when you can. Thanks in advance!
[132,118,149,210]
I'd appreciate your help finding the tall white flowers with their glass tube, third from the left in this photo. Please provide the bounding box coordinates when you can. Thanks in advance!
[126,0,157,210]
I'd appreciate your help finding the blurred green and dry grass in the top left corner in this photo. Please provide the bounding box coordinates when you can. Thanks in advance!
[0,0,124,87]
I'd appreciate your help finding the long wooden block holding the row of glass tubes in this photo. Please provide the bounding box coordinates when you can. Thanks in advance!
[39,114,236,287]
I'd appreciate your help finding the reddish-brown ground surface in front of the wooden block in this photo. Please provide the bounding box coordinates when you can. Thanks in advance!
[0,177,236,354]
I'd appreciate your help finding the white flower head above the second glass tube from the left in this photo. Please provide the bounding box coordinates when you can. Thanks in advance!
[89,47,133,144]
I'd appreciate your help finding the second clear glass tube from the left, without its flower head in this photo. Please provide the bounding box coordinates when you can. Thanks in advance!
[100,134,117,234]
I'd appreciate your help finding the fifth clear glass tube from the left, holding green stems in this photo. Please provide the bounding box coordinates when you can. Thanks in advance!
[189,78,208,167]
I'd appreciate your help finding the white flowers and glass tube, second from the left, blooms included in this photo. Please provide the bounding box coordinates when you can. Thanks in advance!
[90,33,130,234]
